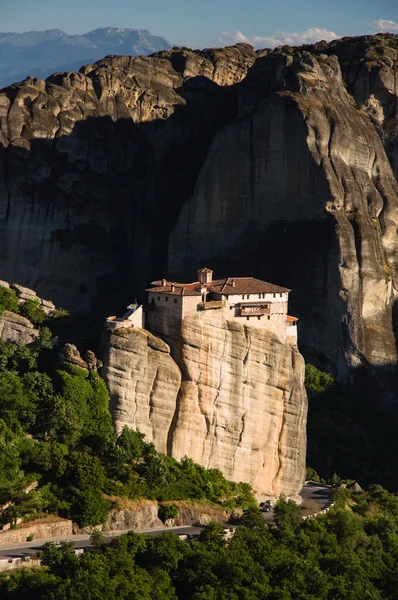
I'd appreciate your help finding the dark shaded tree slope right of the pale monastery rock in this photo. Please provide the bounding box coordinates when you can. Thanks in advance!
[305,365,398,491]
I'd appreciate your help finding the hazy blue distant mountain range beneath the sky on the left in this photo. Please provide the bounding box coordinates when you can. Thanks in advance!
[0,27,172,87]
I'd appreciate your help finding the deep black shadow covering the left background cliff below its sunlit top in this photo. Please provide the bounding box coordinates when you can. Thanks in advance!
[0,76,237,320]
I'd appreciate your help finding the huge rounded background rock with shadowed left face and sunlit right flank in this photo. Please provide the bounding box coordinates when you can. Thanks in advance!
[168,45,398,400]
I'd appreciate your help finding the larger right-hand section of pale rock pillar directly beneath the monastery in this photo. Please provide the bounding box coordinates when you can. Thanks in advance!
[171,311,307,496]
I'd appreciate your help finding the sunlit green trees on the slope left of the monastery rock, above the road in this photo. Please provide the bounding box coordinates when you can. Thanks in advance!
[0,336,255,527]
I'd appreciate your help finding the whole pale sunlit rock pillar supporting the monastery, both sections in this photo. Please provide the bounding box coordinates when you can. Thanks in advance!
[103,310,307,496]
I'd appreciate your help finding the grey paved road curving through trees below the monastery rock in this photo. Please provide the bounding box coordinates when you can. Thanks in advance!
[0,483,330,560]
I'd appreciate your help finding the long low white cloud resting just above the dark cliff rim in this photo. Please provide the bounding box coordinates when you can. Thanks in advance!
[218,27,338,48]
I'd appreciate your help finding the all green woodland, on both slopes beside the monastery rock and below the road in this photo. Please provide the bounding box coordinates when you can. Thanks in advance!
[0,288,398,600]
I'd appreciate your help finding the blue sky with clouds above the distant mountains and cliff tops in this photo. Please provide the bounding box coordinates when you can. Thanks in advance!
[0,0,398,48]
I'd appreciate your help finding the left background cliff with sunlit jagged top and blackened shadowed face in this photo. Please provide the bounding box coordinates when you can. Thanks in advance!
[0,44,256,314]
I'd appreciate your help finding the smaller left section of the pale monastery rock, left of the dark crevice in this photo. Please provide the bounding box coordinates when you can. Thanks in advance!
[103,329,181,453]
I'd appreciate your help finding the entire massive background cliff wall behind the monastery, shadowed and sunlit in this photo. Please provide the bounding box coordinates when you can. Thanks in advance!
[0,35,398,402]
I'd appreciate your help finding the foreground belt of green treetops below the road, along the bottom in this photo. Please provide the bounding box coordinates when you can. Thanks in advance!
[0,486,398,600]
